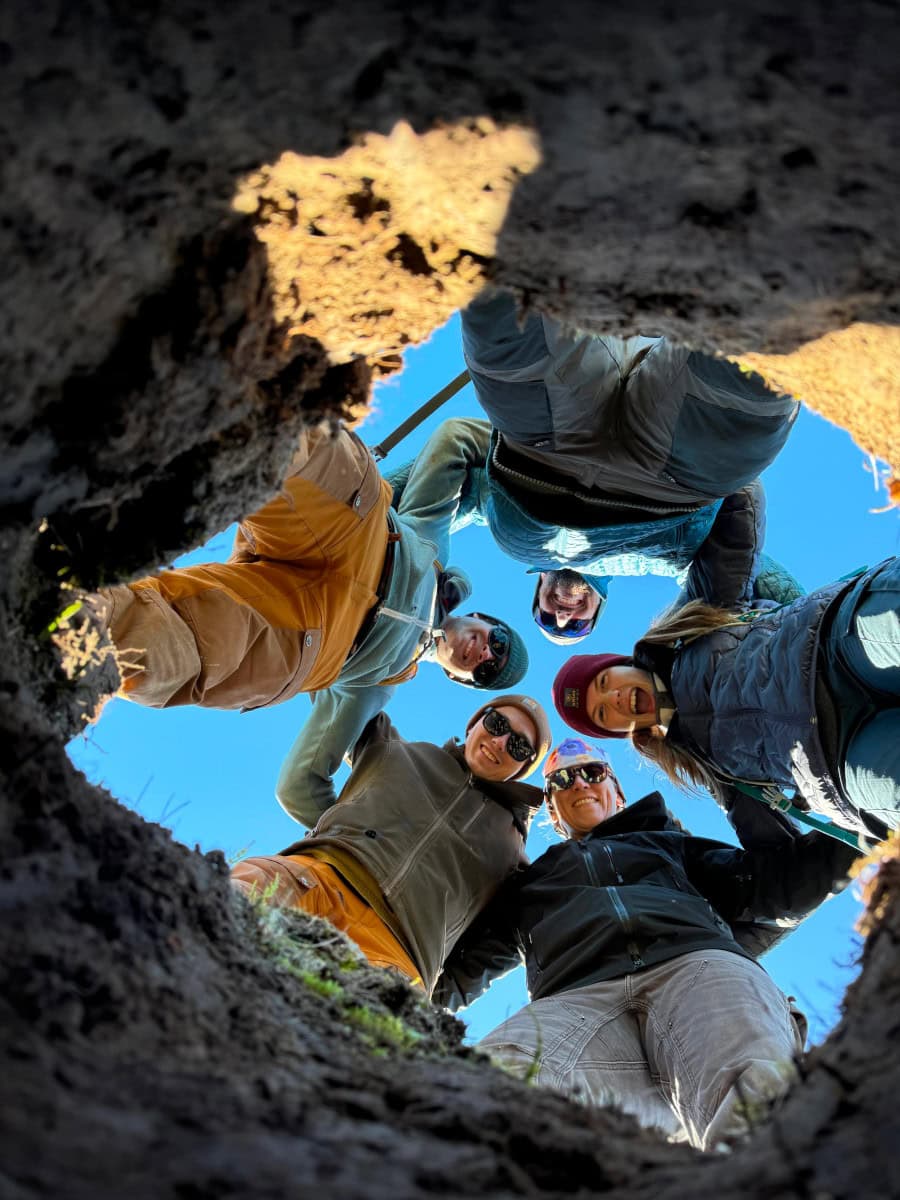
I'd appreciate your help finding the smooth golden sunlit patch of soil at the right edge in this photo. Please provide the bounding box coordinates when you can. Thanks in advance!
[737,324,900,487]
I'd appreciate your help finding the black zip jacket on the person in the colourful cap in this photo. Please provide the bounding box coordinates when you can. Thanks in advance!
[433,792,857,1010]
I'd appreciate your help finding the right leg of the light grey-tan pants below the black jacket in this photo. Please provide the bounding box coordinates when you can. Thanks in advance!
[629,950,803,1150]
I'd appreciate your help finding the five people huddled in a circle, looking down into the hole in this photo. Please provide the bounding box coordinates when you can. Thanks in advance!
[91,285,900,1148]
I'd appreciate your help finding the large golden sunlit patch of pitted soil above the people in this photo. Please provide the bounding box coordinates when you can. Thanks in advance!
[234,118,540,374]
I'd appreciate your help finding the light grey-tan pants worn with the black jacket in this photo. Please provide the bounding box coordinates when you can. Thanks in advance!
[479,950,805,1150]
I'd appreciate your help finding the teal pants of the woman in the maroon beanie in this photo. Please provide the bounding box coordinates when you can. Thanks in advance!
[823,558,900,829]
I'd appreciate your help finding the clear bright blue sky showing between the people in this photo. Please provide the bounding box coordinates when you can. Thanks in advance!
[68,318,900,1042]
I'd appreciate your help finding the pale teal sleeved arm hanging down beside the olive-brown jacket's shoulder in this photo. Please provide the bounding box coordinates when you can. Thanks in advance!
[275,685,396,829]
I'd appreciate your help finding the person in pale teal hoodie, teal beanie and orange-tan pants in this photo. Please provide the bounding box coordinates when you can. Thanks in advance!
[90,424,528,809]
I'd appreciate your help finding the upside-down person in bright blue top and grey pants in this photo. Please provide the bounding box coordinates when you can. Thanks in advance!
[400,288,800,641]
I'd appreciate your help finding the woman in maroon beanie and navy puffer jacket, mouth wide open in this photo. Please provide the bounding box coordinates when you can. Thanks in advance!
[553,558,900,839]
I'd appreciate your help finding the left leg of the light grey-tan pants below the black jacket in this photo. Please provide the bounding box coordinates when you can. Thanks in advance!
[478,979,680,1135]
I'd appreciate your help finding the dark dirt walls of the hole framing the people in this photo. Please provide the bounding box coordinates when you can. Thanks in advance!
[0,0,900,1198]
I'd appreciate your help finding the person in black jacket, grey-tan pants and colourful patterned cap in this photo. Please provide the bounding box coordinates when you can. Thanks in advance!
[434,738,858,1150]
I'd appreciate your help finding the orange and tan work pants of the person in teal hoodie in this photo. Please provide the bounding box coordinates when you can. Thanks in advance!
[100,430,391,708]
